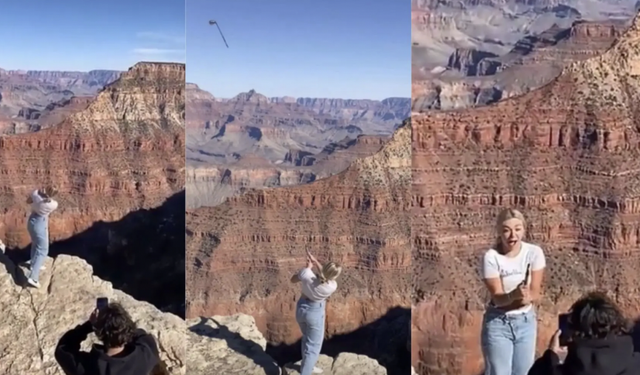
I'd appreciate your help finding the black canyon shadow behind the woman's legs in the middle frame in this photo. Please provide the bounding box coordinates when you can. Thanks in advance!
[267,307,411,375]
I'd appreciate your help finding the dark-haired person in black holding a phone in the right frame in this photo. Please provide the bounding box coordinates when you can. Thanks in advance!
[529,292,640,375]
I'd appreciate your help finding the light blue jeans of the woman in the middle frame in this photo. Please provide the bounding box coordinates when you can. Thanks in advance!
[296,297,326,375]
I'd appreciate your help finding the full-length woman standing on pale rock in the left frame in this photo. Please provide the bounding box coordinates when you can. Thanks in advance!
[26,186,58,288]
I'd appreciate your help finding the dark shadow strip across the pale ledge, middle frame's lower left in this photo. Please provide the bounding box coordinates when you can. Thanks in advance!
[189,317,281,375]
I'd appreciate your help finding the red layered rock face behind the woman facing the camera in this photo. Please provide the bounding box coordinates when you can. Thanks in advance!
[412,11,640,375]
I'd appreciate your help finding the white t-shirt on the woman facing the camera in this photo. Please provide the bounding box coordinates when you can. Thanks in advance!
[482,242,546,314]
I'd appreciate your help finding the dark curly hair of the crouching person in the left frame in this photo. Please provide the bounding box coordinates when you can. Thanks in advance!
[94,302,137,348]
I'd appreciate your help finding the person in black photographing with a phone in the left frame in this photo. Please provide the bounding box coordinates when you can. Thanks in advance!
[55,298,160,375]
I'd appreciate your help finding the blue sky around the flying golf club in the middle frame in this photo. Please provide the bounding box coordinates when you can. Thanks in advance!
[186,0,411,99]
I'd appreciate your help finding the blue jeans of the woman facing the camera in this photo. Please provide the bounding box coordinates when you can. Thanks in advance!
[482,308,538,375]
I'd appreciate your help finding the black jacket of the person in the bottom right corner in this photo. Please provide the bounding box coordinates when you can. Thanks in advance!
[529,336,640,375]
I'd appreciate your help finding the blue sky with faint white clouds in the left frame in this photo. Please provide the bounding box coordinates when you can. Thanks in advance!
[0,0,185,71]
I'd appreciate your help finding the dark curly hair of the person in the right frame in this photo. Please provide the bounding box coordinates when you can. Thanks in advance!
[567,291,630,339]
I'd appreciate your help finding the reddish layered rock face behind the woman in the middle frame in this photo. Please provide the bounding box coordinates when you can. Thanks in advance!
[186,123,411,368]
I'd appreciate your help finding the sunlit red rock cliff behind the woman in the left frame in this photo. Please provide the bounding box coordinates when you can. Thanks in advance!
[0,63,185,247]
